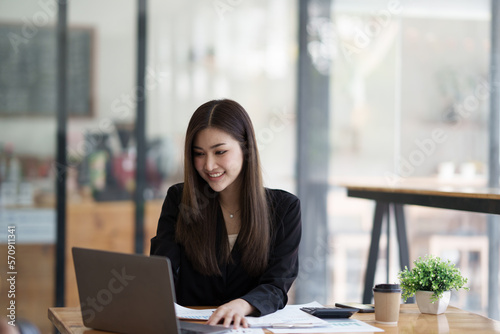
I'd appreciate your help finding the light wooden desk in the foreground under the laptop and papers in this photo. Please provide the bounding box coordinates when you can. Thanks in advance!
[49,304,500,334]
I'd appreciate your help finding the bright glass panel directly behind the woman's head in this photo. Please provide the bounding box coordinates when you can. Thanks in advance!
[147,0,297,193]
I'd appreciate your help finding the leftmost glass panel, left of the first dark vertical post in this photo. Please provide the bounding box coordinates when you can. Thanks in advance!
[0,0,57,333]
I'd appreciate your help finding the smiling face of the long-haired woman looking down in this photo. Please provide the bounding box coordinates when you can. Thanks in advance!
[193,128,243,192]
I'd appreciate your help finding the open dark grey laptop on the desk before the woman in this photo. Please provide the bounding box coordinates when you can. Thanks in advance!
[72,247,230,334]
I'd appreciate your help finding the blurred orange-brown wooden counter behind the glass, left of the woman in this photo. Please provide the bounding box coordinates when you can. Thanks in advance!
[0,200,163,334]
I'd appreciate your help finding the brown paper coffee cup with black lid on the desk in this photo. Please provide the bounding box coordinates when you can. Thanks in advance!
[373,284,401,325]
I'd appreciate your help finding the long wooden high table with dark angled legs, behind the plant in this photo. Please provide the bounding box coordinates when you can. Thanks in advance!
[345,184,500,305]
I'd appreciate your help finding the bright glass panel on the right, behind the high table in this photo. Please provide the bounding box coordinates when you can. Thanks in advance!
[329,1,490,314]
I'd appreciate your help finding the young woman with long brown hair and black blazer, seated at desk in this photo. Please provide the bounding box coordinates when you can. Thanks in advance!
[151,100,301,328]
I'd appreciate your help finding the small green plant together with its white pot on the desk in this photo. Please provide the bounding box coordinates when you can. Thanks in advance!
[398,255,469,314]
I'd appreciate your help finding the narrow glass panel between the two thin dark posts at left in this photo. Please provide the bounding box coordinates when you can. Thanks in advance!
[65,0,142,306]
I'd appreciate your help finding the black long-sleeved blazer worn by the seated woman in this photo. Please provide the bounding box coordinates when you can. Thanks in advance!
[151,183,301,315]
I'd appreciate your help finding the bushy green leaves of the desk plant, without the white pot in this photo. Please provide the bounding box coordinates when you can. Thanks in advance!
[398,255,469,303]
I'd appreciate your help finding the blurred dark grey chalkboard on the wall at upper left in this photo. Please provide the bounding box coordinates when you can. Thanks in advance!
[0,24,93,116]
